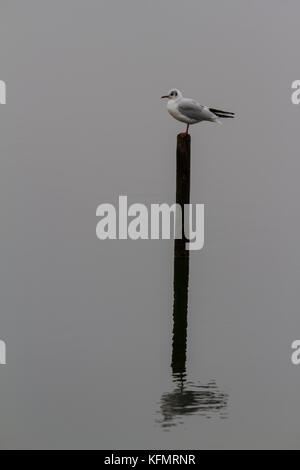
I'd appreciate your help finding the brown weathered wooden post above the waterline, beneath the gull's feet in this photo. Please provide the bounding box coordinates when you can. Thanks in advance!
[175,134,191,257]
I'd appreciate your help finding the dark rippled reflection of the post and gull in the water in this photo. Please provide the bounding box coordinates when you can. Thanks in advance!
[159,253,228,430]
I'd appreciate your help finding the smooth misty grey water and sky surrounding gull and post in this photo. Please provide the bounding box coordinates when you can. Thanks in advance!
[0,0,300,449]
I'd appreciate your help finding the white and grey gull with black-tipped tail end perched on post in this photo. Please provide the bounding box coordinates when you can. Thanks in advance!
[162,88,235,136]
